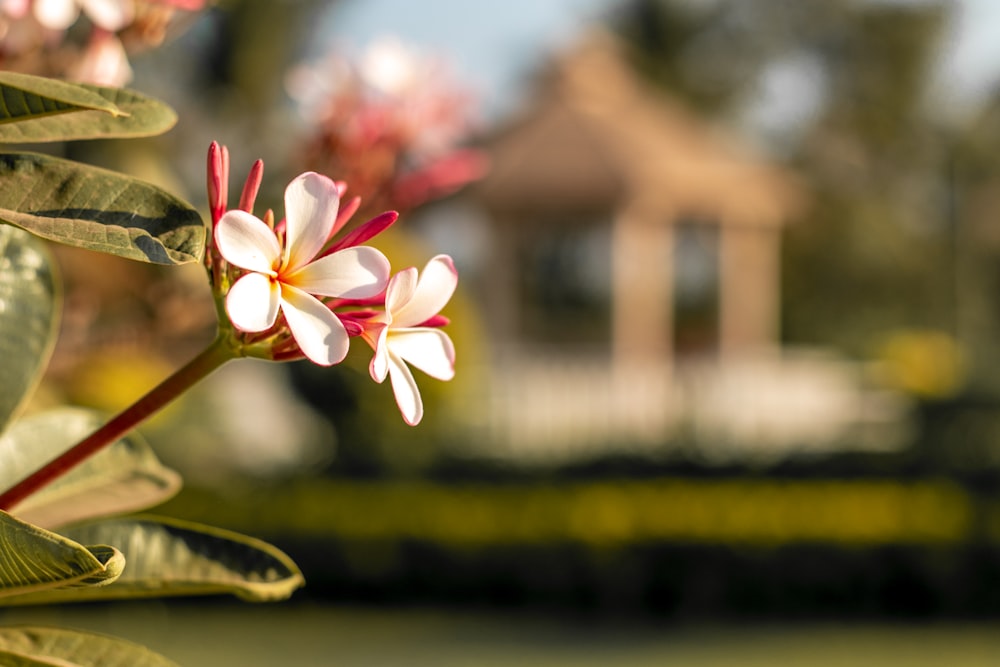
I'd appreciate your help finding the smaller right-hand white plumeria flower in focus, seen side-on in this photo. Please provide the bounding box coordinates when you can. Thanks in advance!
[363,255,458,426]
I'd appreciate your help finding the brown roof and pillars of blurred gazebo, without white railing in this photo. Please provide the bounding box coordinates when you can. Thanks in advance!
[478,33,802,370]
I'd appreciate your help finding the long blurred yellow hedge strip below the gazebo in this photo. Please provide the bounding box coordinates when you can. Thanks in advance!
[252,479,975,546]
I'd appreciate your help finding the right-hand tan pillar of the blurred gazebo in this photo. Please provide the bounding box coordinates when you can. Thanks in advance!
[719,223,781,356]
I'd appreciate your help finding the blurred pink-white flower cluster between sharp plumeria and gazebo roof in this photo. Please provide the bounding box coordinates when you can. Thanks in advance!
[287,39,486,217]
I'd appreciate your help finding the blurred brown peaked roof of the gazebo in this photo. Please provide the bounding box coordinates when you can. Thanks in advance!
[476,32,803,226]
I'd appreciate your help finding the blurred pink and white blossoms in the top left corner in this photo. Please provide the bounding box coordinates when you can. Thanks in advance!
[0,0,207,86]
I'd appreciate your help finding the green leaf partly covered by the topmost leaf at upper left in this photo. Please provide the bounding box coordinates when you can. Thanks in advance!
[0,85,177,143]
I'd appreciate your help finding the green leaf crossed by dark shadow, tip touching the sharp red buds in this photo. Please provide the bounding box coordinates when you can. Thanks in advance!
[0,153,205,264]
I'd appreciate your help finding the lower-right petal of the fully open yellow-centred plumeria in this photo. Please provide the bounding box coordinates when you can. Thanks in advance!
[281,285,350,366]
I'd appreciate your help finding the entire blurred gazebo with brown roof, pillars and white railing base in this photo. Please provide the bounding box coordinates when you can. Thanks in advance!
[450,33,904,458]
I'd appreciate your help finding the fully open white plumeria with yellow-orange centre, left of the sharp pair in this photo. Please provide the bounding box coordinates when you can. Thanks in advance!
[215,172,389,366]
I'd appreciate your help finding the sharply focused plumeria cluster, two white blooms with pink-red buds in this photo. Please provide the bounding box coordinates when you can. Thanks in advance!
[205,143,458,425]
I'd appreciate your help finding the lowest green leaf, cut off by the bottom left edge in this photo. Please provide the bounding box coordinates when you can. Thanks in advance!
[0,626,177,667]
